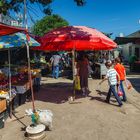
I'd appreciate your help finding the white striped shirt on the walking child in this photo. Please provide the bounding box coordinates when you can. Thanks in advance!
[106,68,117,85]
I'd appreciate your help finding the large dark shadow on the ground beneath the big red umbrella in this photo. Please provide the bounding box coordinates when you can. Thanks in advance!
[35,82,82,104]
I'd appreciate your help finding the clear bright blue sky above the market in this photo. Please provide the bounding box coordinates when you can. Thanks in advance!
[26,0,140,37]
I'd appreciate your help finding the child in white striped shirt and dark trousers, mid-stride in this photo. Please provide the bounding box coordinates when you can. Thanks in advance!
[99,61,123,107]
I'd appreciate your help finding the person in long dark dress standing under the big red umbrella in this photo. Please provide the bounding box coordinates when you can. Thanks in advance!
[77,54,89,96]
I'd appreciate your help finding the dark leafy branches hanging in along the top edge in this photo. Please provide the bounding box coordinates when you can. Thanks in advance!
[0,0,85,15]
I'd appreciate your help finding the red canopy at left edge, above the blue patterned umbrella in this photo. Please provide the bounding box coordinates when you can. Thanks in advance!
[0,23,26,36]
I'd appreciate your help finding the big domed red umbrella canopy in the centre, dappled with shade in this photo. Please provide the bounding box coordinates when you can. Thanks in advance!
[34,26,117,51]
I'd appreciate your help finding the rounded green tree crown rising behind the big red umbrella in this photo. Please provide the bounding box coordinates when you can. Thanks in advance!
[32,15,69,36]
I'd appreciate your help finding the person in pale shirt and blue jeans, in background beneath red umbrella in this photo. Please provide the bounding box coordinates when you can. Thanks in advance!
[50,53,61,79]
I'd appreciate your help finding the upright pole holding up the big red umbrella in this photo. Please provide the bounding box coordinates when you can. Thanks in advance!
[72,49,75,99]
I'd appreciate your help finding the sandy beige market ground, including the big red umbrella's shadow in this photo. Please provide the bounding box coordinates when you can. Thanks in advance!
[0,76,140,140]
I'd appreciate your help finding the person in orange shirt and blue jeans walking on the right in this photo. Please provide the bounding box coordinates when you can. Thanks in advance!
[114,57,127,102]
